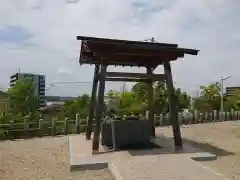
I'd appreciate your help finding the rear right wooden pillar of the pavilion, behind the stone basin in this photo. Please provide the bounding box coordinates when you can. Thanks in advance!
[147,67,156,137]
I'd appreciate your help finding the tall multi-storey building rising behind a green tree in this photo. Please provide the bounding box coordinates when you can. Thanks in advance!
[10,73,46,108]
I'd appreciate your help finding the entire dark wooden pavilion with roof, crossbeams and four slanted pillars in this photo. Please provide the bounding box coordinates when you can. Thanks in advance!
[77,36,199,153]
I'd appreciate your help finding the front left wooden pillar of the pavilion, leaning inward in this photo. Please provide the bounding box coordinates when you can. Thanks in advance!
[92,64,107,154]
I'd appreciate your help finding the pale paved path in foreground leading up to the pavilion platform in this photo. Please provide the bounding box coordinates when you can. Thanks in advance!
[114,155,225,180]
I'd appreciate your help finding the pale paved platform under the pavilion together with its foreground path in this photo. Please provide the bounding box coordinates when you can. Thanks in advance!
[69,135,226,180]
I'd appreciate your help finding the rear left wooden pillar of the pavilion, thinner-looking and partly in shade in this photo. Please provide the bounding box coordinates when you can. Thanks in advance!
[86,65,99,140]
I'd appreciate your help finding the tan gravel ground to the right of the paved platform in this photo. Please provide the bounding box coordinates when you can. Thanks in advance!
[158,121,240,180]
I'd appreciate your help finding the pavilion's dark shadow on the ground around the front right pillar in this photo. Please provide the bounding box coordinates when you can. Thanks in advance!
[128,135,234,157]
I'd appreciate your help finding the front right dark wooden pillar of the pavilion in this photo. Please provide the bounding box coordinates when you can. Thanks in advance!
[163,61,182,147]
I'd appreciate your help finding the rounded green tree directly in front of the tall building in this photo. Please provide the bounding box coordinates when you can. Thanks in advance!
[7,79,38,118]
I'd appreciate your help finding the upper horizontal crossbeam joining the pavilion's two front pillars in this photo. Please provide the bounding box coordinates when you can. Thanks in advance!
[106,72,166,81]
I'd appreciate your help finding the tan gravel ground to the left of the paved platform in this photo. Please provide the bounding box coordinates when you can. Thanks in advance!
[0,136,113,180]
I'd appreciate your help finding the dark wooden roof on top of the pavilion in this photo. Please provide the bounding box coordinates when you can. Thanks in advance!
[77,36,199,68]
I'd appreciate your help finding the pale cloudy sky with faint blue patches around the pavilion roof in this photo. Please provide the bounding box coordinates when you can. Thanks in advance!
[0,0,240,95]
